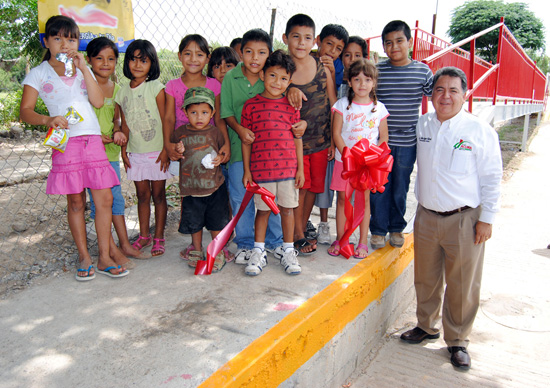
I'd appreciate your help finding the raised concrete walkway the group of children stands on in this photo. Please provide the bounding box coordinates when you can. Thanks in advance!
[0,174,415,388]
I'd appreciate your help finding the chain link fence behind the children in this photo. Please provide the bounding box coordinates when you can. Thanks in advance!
[0,0,369,296]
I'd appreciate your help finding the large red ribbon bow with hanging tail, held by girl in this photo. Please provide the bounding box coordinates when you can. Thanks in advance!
[339,139,393,259]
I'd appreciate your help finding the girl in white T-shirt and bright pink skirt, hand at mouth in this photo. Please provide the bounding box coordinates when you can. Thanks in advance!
[20,16,129,281]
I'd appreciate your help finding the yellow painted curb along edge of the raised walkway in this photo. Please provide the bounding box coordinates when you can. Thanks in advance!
[199,234,414,388]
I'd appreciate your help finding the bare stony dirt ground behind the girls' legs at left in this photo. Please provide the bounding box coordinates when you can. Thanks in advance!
[0,132,179,298]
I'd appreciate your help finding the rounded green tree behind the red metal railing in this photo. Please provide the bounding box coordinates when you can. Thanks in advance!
[447,0,545,63]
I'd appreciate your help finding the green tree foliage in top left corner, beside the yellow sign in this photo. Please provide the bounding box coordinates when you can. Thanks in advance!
[0,0,43,65]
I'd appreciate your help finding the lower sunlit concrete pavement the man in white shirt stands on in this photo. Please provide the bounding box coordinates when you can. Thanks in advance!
[350,121,550,388]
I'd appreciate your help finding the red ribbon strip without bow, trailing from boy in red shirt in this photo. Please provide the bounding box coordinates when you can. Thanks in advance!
[195,183,279,275]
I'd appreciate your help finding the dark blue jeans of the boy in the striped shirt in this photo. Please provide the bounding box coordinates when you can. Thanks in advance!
[370,145,416,236]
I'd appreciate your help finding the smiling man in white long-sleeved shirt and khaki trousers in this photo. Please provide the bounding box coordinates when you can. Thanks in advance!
[401,67,502,369]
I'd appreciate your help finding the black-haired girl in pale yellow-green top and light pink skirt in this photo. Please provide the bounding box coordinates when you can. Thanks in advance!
[115,39,172,256]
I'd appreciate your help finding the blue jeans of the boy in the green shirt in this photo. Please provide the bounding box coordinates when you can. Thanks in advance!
[227,162,283,249]
